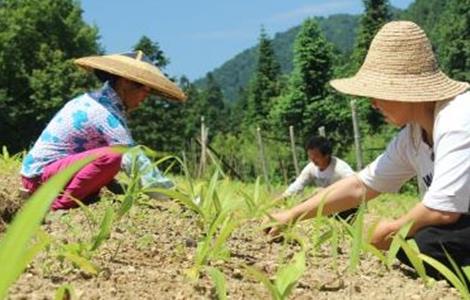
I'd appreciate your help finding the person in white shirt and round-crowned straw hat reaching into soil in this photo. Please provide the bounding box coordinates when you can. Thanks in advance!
[267,21,470,276]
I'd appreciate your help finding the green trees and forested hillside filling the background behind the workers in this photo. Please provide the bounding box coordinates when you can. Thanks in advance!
[0,0,470,183]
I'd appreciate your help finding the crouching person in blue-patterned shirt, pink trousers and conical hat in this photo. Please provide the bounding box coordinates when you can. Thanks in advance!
[21,51,186,210]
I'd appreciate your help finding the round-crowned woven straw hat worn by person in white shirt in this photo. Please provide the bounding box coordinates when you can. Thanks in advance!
[330,21,470,102]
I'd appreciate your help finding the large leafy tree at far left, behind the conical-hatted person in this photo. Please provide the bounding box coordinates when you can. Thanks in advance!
[0,0,100,151]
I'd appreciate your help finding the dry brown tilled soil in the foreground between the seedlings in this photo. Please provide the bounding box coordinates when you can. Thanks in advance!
[2,195,460,299]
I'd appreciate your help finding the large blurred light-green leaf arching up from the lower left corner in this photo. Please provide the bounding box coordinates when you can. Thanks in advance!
[0,156,95,299]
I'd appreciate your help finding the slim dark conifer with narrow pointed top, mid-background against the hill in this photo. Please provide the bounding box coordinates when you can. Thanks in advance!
[245,28,280,127]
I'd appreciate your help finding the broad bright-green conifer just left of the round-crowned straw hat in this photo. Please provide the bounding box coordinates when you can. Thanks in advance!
[271,18,333,139]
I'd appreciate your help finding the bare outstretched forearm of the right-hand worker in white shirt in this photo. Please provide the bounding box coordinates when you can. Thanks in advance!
[289,176,379,219]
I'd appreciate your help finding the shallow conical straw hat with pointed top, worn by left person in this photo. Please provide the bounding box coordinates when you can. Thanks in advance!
[74,50,186,101]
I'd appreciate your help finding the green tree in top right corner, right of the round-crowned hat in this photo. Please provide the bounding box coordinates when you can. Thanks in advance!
[435,0,470,82]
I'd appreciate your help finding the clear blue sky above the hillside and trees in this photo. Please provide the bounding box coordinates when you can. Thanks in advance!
[81,0,413,80]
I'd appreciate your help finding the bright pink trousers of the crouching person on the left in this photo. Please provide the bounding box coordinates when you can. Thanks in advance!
[22,147,122,210]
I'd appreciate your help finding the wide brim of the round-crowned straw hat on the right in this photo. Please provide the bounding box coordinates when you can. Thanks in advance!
[330,71,470,102]
